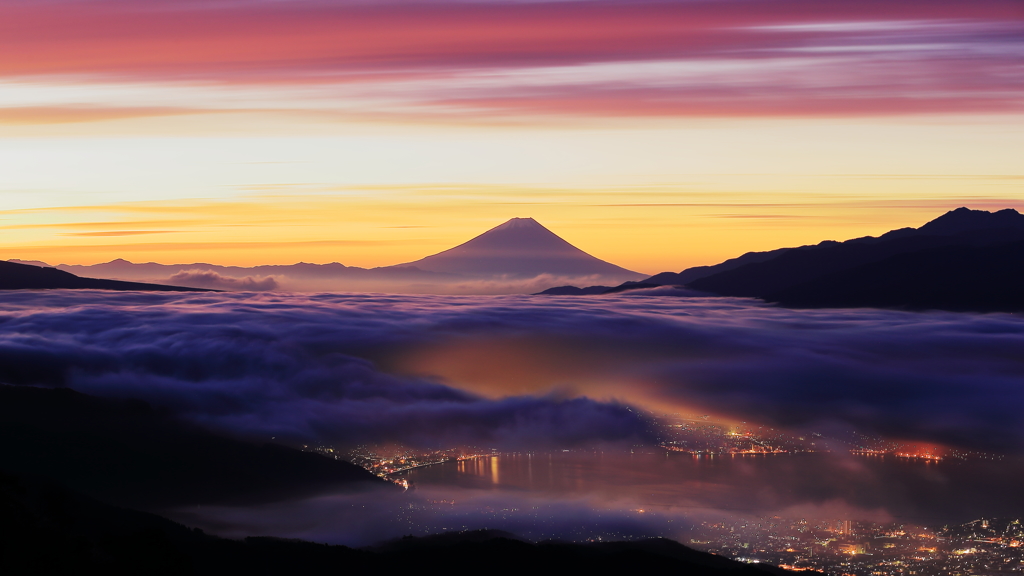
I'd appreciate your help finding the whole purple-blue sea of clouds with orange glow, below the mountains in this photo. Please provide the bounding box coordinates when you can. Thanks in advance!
[0,292,1024,452]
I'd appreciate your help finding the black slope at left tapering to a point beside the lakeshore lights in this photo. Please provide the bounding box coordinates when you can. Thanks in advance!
[0,385,385,509]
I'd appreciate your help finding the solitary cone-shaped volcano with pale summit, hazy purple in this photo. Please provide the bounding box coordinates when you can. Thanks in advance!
[390,218,643,282]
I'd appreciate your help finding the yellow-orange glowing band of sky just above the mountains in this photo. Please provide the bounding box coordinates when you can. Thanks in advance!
[0,175,1024,274]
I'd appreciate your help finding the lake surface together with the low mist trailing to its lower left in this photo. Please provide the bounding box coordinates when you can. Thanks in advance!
[170,451,1024,545]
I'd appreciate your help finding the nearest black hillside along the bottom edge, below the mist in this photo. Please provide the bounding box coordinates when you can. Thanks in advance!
[0,474,798,576]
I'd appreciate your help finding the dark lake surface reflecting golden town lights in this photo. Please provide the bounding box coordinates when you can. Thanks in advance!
[407,452,1024,521]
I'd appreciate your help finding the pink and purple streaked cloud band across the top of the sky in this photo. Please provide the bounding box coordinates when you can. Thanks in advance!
[0,0,1024,122]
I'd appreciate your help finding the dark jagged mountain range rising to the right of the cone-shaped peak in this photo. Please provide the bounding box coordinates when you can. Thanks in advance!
[542,208,1024,312]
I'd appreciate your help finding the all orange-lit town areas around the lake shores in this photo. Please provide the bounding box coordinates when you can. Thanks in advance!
[306,414,1024,576]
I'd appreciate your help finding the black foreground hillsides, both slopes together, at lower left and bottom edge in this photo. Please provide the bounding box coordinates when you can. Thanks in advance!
[0,385,815,576]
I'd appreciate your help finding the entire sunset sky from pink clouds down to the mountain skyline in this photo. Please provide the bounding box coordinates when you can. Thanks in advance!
[0,0,1024,274]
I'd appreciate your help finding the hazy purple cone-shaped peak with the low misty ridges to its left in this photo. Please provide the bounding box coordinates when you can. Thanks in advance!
[12,218,644,293]
